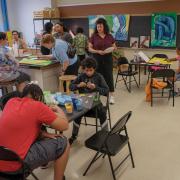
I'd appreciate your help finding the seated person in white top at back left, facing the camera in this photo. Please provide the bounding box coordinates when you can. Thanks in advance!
[12,30,27,55]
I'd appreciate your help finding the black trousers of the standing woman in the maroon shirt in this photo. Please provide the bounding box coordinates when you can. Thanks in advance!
[94,53,114,92]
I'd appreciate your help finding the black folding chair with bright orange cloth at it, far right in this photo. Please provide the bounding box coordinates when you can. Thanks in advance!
[150,69,175,106]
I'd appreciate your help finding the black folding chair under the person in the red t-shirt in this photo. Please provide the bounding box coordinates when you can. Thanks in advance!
[0,146,38,180]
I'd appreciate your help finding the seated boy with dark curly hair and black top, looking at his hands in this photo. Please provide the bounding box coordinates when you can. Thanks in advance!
[69,57,109,144]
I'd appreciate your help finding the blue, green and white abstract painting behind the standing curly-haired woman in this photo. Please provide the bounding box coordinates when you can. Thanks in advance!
[89,15,130,41]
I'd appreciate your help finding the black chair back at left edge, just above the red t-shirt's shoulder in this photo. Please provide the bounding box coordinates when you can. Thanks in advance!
[0,91,21,110]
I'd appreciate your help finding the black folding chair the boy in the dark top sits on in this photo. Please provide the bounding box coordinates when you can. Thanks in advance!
[81,93,112,132]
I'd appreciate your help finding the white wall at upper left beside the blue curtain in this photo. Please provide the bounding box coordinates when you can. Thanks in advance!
[7,0,51,43]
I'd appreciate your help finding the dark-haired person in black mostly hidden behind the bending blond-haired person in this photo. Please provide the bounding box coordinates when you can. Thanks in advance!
[41,22,53,55]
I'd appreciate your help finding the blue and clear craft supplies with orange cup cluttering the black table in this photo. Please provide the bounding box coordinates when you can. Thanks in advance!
[43,91,99,114]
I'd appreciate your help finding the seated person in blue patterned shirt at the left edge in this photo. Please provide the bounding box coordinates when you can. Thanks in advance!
[0,32,30,91]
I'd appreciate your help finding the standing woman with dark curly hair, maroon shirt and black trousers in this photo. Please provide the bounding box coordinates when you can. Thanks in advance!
[89,18,116,104]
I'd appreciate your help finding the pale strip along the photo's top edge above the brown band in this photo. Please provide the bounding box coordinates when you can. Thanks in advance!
[56,0,157,6]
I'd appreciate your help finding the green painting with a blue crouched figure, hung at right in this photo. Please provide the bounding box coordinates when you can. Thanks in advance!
[151,13,177,47]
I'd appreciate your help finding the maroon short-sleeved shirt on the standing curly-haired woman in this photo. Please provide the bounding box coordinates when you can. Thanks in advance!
[89,34,115,51]
